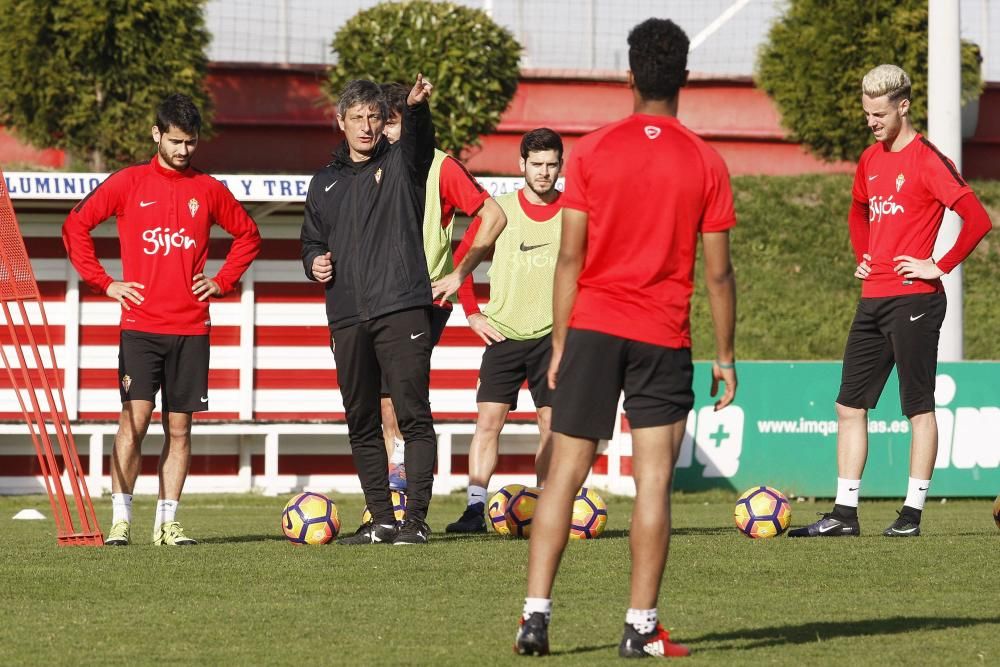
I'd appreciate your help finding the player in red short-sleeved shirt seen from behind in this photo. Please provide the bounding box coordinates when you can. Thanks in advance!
[515,19,736,657]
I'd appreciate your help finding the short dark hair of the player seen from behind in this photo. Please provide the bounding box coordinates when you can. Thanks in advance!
[628,19,690,100]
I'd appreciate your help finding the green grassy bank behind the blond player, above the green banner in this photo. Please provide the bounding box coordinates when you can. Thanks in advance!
[691,174,1000,360]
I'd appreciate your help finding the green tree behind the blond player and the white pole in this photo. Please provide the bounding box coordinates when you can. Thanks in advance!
[756,0,983,160]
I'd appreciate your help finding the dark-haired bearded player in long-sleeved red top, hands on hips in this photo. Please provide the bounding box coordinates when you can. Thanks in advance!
[63,94,260,546]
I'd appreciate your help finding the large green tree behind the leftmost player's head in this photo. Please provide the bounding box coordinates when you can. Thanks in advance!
[0,0,211,171]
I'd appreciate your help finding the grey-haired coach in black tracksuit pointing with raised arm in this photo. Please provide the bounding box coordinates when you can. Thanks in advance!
[301,75,437,544]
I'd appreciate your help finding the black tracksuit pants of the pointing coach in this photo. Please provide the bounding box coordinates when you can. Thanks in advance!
[333,306,437,524]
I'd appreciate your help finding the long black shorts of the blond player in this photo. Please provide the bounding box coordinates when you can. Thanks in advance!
[837,292,948,417]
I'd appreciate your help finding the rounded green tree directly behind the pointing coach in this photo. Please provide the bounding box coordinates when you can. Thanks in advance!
[324,0,521,154]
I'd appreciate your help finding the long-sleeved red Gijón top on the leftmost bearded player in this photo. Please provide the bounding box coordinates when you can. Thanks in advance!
[63,156,260,336]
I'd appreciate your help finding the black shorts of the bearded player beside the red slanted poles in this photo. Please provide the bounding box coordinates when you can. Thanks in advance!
[118,330,209,412]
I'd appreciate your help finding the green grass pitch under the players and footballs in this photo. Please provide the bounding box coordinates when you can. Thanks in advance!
[0,491,1000,665]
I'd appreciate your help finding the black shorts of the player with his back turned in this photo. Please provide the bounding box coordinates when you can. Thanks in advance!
[552,329,694,440]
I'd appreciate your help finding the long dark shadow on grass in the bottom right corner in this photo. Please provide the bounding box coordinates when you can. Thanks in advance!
[684,616,1000,651]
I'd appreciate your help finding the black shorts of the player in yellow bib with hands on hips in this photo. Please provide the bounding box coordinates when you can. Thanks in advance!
[476,335,552,410]
